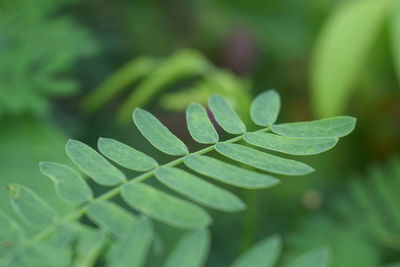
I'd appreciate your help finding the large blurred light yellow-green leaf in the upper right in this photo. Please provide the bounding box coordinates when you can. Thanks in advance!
[311,0,399,117]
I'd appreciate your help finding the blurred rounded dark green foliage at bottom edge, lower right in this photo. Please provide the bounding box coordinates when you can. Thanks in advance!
[285,217,381,267]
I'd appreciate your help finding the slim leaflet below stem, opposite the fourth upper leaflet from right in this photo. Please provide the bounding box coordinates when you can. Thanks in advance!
[184,155,279,189]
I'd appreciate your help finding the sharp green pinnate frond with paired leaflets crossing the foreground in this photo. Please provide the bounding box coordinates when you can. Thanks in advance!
[3,91,355,266]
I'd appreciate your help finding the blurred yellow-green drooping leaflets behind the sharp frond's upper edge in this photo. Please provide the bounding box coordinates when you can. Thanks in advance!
[84,50,250,122]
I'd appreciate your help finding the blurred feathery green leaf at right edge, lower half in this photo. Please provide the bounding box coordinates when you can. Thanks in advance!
[335,157,400,251]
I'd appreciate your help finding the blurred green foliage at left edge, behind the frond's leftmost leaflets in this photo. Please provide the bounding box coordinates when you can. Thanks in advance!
[0,119,68,219]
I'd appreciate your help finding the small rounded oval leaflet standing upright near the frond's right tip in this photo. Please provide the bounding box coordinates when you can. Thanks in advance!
[250,90,281,126]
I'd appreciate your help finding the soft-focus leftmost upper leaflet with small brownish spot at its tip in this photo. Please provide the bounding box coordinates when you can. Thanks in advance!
[7,184,57,226]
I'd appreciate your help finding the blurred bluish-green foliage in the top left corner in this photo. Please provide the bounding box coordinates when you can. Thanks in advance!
[0,0,98,116]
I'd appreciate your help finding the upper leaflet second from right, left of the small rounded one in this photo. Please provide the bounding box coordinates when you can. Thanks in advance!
[208,94,246,134]
